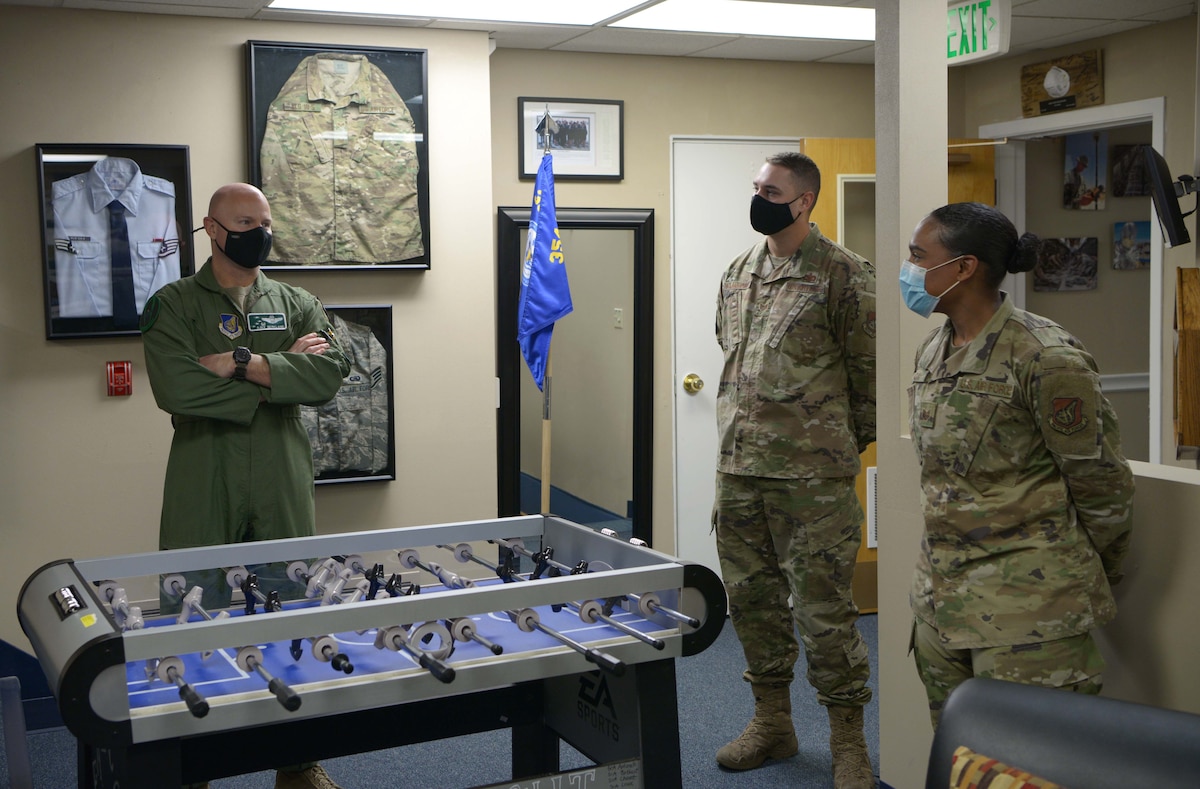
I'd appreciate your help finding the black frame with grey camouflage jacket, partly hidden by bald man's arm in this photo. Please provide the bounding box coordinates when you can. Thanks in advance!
[300,305,396,484]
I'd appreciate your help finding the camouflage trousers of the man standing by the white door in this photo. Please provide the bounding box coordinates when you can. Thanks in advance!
[713,474,871,706]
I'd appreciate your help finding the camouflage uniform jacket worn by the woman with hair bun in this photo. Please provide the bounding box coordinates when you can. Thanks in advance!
[910,296,1134,649]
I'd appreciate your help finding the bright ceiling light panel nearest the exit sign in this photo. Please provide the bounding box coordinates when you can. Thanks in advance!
[608,0,875,41]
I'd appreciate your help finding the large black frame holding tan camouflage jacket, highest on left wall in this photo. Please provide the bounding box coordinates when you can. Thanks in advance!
[246,41,430,271]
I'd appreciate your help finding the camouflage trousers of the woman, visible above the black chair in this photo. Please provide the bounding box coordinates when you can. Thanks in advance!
[910,618,1104,730]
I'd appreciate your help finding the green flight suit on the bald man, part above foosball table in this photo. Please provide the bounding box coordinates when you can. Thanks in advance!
[142,259,349,548]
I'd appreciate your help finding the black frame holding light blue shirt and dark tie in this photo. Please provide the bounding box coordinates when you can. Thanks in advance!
[34,143,196,339]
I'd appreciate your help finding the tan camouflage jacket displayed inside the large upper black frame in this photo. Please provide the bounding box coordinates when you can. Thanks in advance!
[259,53,424,265]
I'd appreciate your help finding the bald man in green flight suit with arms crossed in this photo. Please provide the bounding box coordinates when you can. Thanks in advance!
[142,183,349,789]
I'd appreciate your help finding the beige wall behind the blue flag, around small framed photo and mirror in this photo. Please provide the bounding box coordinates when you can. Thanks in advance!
[492,49,875,552]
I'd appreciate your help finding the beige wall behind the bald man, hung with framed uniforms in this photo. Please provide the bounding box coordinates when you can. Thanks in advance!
[0,6,496,649]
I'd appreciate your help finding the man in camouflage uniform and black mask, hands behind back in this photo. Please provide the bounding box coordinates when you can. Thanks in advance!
[713,152,875,789]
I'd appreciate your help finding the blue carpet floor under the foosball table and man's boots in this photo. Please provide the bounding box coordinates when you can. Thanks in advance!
[0,615,880,789]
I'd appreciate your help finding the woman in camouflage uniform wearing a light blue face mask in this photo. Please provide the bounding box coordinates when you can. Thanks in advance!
[900,203,1134,727]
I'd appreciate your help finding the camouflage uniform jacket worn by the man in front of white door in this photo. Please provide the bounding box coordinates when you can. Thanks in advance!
[716,224,875,480]
